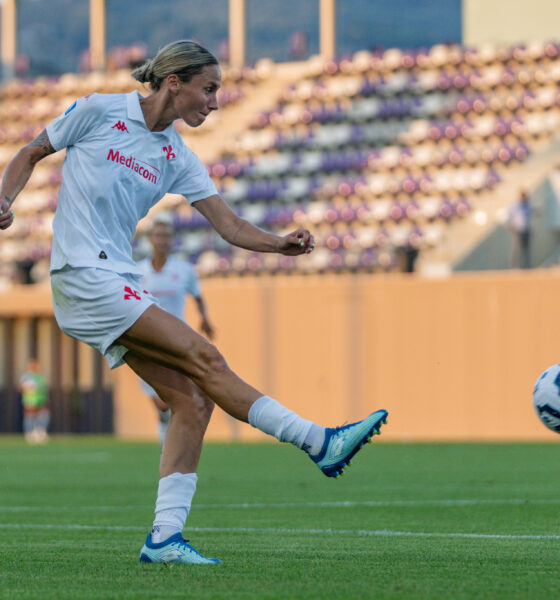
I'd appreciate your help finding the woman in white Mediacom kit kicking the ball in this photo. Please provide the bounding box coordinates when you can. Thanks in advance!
[0,40,387,563]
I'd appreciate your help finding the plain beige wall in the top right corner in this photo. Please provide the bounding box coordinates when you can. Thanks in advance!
[463,0,560,46]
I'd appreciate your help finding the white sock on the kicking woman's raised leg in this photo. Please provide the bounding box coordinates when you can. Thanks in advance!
[249,396,325,454]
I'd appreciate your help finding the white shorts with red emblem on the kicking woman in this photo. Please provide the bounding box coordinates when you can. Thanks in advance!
[51,266,157,369]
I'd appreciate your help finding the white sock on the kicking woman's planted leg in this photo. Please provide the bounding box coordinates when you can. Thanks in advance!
[152,473,197,544]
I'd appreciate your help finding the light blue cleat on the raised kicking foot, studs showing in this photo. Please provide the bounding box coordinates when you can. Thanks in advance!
[309,410,388,477]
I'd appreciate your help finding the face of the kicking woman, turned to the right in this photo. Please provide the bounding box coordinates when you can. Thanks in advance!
[174,65,222,127]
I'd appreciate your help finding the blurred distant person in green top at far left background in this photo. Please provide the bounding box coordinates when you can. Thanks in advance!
[19,358,50,444]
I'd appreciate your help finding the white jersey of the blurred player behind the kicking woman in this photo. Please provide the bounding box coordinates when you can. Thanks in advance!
[137,256,200,321]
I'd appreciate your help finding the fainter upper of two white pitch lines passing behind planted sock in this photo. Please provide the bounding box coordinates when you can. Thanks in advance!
[0,498,560,512]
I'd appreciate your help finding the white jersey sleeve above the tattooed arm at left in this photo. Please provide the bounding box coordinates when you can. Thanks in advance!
[47,94,105,151]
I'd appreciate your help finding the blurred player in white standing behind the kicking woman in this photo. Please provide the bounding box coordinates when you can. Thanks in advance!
[138,212,214,445]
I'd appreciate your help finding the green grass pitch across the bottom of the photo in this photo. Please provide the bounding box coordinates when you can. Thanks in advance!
[0,437,560,600]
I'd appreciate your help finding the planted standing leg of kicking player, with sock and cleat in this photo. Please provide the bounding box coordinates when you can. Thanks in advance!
[125,352,217,564]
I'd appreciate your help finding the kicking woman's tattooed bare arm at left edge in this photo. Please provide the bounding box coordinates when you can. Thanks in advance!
[0,129,55,229]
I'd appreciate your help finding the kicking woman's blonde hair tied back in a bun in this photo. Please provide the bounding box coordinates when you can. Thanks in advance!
[131,40,219,91]
